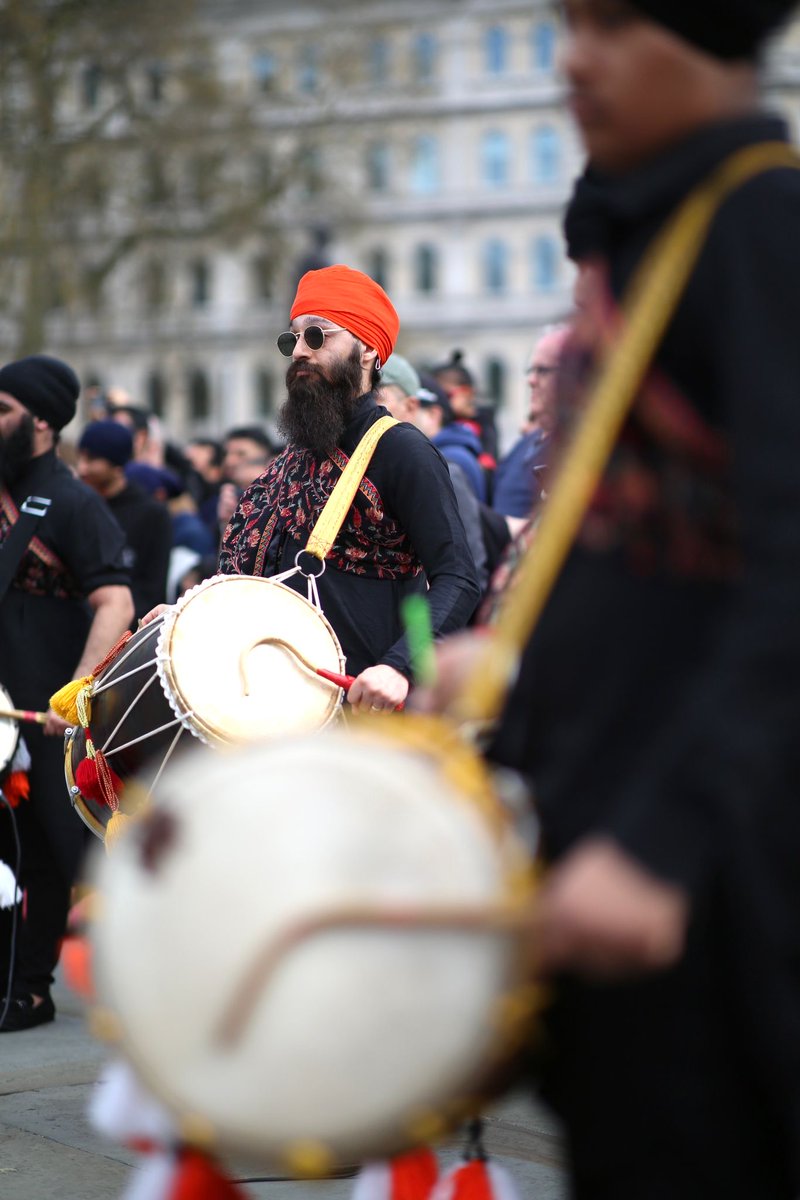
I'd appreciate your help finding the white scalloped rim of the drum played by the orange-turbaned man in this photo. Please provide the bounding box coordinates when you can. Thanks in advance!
[156,574,345,749]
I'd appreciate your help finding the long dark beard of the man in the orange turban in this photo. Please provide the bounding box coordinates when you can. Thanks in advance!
[278,346,361,458]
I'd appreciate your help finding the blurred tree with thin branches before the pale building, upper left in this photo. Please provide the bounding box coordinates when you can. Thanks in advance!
[0,0,293,354]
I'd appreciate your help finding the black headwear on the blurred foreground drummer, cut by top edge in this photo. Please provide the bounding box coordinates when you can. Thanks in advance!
[630,0,798,61]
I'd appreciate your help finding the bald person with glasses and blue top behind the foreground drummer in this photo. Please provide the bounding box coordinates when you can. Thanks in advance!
[492,325,570,520]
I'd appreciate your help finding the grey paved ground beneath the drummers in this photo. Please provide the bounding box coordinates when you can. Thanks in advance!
[0,986,566,1200]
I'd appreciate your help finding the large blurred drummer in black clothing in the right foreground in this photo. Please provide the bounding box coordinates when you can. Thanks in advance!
[443,0,800,1200]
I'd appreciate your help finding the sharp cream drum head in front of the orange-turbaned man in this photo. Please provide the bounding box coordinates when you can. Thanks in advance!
[157,575,344,745]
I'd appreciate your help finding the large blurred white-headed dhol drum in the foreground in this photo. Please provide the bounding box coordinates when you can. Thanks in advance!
[94,716,537,1175]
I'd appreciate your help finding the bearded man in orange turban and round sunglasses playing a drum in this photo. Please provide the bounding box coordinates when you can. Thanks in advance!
[219,265,479,709]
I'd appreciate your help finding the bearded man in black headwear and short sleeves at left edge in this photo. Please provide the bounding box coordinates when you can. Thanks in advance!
[0,354,133,1032]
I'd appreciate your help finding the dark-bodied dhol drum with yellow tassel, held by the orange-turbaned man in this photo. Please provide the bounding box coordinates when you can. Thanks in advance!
[65,575,344,838]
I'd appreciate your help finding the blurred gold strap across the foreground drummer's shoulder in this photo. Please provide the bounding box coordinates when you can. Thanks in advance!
[451,142,800,722]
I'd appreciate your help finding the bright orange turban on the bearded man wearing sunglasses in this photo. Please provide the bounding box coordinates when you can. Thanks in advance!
[291,263,399,362]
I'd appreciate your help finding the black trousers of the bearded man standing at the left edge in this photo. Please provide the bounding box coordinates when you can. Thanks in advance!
[0,726,90,995]
